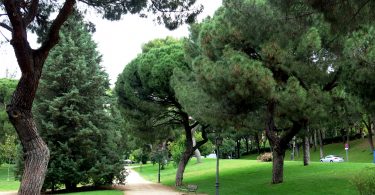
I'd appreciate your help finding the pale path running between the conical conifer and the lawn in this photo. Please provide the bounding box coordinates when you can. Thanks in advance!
[116,169,182,195]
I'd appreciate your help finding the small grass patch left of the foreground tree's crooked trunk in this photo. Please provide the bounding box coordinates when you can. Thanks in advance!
[0,164,20,191]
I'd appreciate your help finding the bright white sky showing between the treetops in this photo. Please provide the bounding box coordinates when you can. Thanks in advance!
[0,0,222,84]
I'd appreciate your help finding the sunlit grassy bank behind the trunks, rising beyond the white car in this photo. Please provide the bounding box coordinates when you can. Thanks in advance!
[242,136,374,163]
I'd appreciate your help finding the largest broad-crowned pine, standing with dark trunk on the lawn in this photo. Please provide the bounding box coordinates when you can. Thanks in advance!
[175,0,339,183]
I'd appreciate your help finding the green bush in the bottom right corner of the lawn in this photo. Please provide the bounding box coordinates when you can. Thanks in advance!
[352,167,375,195]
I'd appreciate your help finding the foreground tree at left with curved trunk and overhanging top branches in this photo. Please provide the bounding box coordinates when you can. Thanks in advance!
[0,0,202,194]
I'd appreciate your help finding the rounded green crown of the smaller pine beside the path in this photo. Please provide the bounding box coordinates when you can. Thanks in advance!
[115,37,187,143]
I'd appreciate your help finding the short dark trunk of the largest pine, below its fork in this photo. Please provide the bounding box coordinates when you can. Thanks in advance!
[272,148,285,184]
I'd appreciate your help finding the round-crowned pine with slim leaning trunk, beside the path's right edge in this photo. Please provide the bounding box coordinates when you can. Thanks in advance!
[116,38,207,186]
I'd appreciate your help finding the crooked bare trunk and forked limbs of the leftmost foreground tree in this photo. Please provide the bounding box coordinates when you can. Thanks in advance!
[2,0,76,195]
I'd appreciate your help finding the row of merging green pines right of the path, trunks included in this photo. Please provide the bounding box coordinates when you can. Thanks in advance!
[115,0,374,186]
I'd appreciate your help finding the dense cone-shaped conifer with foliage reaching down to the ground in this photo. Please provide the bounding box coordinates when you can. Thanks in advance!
[35,15,123,190]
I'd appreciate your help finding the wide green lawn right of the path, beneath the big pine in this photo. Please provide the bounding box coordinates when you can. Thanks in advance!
[135,159,375,195]
